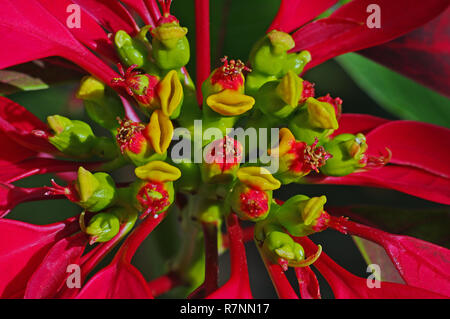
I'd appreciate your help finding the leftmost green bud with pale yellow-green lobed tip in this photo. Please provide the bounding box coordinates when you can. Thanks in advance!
[47,115,96,158]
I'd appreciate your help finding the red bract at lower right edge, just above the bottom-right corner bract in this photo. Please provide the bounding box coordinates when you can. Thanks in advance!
[341,221,450,297]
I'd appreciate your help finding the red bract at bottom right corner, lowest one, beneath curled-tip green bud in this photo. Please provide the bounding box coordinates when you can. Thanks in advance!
[295,237,445,299]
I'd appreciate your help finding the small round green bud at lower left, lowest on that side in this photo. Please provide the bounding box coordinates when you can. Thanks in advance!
[85,212,120,245]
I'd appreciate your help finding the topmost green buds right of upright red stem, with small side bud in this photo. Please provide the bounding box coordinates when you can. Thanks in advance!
[246,30,311,95]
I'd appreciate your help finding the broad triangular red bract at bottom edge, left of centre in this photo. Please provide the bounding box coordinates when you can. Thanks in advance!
[76,259,153,299]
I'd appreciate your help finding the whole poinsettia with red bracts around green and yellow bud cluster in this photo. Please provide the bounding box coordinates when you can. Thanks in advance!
[0,0,450,299]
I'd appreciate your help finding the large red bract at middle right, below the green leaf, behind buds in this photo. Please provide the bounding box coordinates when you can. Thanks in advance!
[308,114,450,204]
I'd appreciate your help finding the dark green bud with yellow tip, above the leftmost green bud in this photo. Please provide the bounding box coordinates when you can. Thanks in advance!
[77,76,125,131]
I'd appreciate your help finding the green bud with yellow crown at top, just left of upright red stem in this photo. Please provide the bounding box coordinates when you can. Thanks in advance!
[151,21,190,70]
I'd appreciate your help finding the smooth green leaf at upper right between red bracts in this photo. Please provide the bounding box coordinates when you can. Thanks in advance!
[336,53,450,127]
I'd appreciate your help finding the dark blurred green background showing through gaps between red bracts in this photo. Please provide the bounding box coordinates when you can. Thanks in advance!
[4,0,450,298]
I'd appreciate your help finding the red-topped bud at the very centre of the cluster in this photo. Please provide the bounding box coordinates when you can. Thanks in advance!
[200,136,243,183]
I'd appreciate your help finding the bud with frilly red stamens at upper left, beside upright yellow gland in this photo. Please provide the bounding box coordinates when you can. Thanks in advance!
[111,64,159,113]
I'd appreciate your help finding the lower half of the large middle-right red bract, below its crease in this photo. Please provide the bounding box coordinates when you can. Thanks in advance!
[307,164,450,205]
